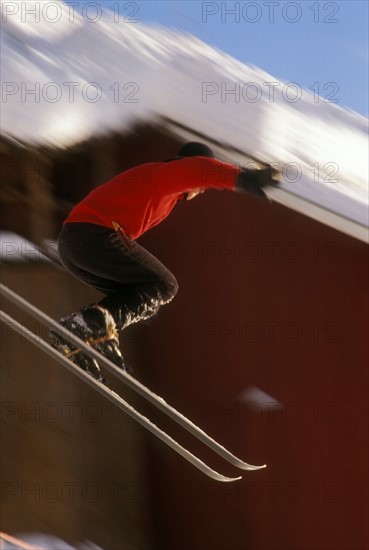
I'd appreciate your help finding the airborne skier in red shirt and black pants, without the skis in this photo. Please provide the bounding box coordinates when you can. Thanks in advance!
[50,142,277,380]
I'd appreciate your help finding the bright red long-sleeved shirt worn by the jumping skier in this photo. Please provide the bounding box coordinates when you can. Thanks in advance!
[65,157,240,239]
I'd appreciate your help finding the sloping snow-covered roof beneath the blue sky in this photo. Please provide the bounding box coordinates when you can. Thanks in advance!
[1,2,369,241]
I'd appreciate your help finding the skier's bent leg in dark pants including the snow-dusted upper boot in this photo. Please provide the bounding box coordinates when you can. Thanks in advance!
[52,223,178,376]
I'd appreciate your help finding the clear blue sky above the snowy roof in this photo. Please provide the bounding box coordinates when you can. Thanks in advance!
[72,0,369,116]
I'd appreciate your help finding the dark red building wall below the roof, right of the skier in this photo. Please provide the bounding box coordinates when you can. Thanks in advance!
[137,188,368,550]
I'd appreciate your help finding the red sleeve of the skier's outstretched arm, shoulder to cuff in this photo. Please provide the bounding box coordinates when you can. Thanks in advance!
[156,157,241,195]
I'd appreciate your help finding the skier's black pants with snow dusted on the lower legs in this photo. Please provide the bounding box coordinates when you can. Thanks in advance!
[58,223,178,330]
